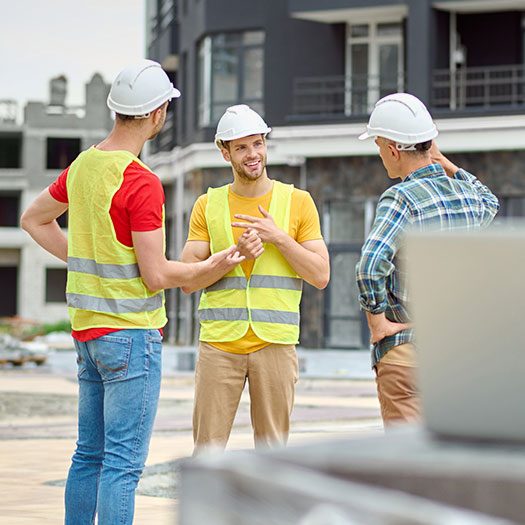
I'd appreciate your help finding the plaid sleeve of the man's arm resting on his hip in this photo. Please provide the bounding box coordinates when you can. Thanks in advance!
[356,188,410,314]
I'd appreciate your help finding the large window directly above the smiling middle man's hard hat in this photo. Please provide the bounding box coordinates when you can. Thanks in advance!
[198,31,264,127]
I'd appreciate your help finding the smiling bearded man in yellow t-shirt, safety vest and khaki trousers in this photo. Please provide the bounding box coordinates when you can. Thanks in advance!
[182,105,330,452]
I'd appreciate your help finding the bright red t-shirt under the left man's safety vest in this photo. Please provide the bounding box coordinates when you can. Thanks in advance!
[49,162,164,341]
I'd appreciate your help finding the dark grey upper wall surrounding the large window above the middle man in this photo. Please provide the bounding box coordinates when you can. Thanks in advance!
[179,0,345,145]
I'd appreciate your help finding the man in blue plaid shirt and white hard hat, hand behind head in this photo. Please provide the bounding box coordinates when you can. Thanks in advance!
[356,93,499,425]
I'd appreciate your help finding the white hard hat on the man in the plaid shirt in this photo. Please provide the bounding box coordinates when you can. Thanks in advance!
[359,93,438,145]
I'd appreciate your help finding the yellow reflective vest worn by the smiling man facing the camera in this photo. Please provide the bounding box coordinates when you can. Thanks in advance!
[198,181,303,344]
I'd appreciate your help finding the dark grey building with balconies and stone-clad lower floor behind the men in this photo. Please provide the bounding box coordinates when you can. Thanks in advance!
[147,0,525,348]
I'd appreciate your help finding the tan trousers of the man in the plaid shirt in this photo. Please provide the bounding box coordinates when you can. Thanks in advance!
[374,346,421,427]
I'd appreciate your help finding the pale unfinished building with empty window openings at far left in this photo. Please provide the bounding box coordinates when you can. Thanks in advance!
[0,74,112,323]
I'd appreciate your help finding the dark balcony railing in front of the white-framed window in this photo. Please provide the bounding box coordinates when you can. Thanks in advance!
[291,75,405,120]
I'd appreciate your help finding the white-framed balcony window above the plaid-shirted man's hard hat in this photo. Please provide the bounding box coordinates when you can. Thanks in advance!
[345,22,404,115]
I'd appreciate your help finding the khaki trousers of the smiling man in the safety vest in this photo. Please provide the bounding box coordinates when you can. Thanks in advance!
[193,342,298,453]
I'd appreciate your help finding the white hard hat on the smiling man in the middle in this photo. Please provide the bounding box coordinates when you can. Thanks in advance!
[215,104,272,147]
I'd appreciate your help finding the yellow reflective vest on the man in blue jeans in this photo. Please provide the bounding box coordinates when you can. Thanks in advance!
[66,148,167,330]
